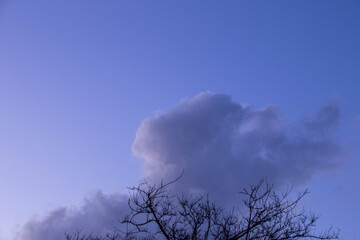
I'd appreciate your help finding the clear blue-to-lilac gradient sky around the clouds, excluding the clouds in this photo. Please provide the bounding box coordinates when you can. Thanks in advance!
[0,0,360,240]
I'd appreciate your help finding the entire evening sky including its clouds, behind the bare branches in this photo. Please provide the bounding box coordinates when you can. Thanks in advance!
[0,0,360,240]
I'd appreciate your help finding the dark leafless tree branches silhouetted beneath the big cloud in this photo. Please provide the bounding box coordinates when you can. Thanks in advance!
[68,179,339,240]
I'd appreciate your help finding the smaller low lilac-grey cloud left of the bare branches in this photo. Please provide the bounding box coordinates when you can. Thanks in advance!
[15,191,128,240]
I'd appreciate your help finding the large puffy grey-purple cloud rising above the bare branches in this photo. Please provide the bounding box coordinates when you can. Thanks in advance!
[132,92,342,202]
